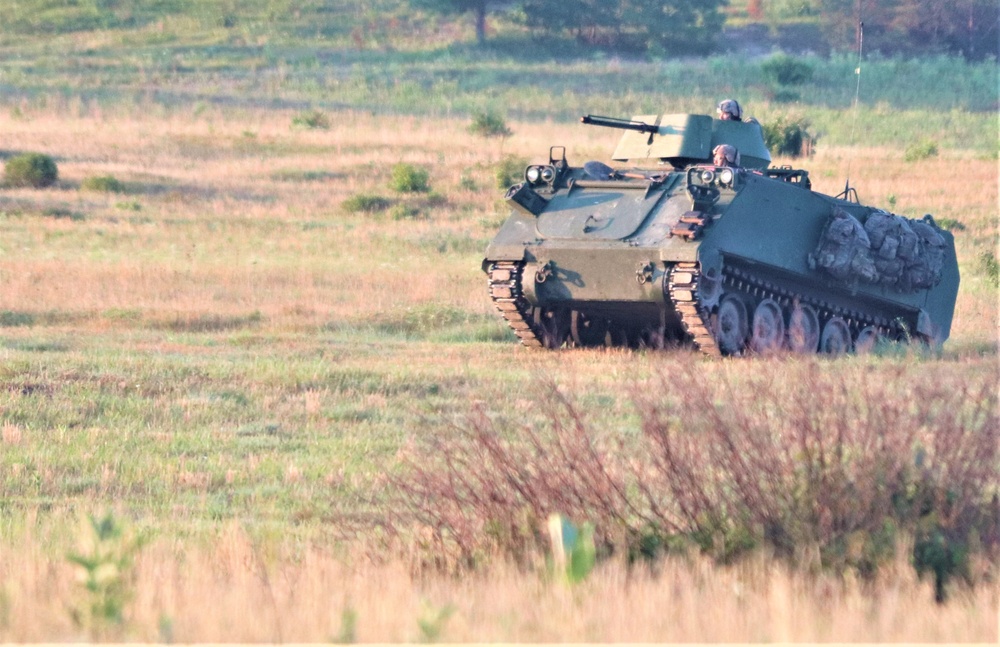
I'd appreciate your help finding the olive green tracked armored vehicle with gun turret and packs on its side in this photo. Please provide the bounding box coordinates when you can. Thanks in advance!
[483,114,959,355]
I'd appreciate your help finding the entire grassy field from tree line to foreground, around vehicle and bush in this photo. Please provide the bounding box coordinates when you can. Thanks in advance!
[0,11,1000,642]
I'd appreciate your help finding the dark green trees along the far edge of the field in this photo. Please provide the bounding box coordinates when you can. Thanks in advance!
[420,0,1000,60]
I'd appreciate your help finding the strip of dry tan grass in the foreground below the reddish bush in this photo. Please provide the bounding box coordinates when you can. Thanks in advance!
[0,526,1000,643]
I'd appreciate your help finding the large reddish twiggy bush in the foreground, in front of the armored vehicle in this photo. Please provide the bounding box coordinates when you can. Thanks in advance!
[394,359,1000,599]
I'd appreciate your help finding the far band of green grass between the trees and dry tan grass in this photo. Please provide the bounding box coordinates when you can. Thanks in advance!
[0,15,998,154]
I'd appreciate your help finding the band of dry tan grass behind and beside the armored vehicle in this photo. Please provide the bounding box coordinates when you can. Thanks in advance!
[0,110,997,346]
